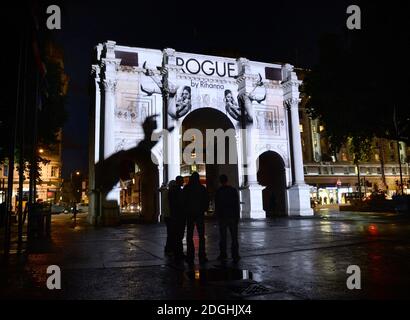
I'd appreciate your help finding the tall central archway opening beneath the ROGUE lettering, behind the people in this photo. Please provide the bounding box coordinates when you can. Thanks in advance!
[181,108,239,210]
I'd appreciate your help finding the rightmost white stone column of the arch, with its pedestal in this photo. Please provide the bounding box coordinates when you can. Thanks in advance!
[282,64,313,216]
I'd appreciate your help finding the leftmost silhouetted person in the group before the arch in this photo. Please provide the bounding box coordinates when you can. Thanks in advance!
[168,176,186,260]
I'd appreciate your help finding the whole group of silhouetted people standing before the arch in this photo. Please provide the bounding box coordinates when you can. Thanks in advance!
[162,172,240,264]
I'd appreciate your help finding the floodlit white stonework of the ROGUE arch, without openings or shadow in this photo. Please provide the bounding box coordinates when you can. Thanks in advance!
[89,41,313,223]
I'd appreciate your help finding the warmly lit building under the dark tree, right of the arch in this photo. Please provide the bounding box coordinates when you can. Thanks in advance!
[299,89,410,205]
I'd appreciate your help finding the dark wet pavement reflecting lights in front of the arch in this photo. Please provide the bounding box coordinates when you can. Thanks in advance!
[0,210,410,300]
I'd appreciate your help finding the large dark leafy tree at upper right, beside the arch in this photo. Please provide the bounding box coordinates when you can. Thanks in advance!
[303,1,410,155]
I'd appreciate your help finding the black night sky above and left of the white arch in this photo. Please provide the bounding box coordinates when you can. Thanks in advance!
[55,0,352,177]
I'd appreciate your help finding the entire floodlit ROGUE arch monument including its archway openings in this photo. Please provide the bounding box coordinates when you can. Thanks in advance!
[89,41,313,223]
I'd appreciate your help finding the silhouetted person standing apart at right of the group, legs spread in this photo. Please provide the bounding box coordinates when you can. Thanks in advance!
[215,174,240,263]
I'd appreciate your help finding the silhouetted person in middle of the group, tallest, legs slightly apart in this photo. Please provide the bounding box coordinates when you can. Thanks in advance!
[183,172,209,264]
